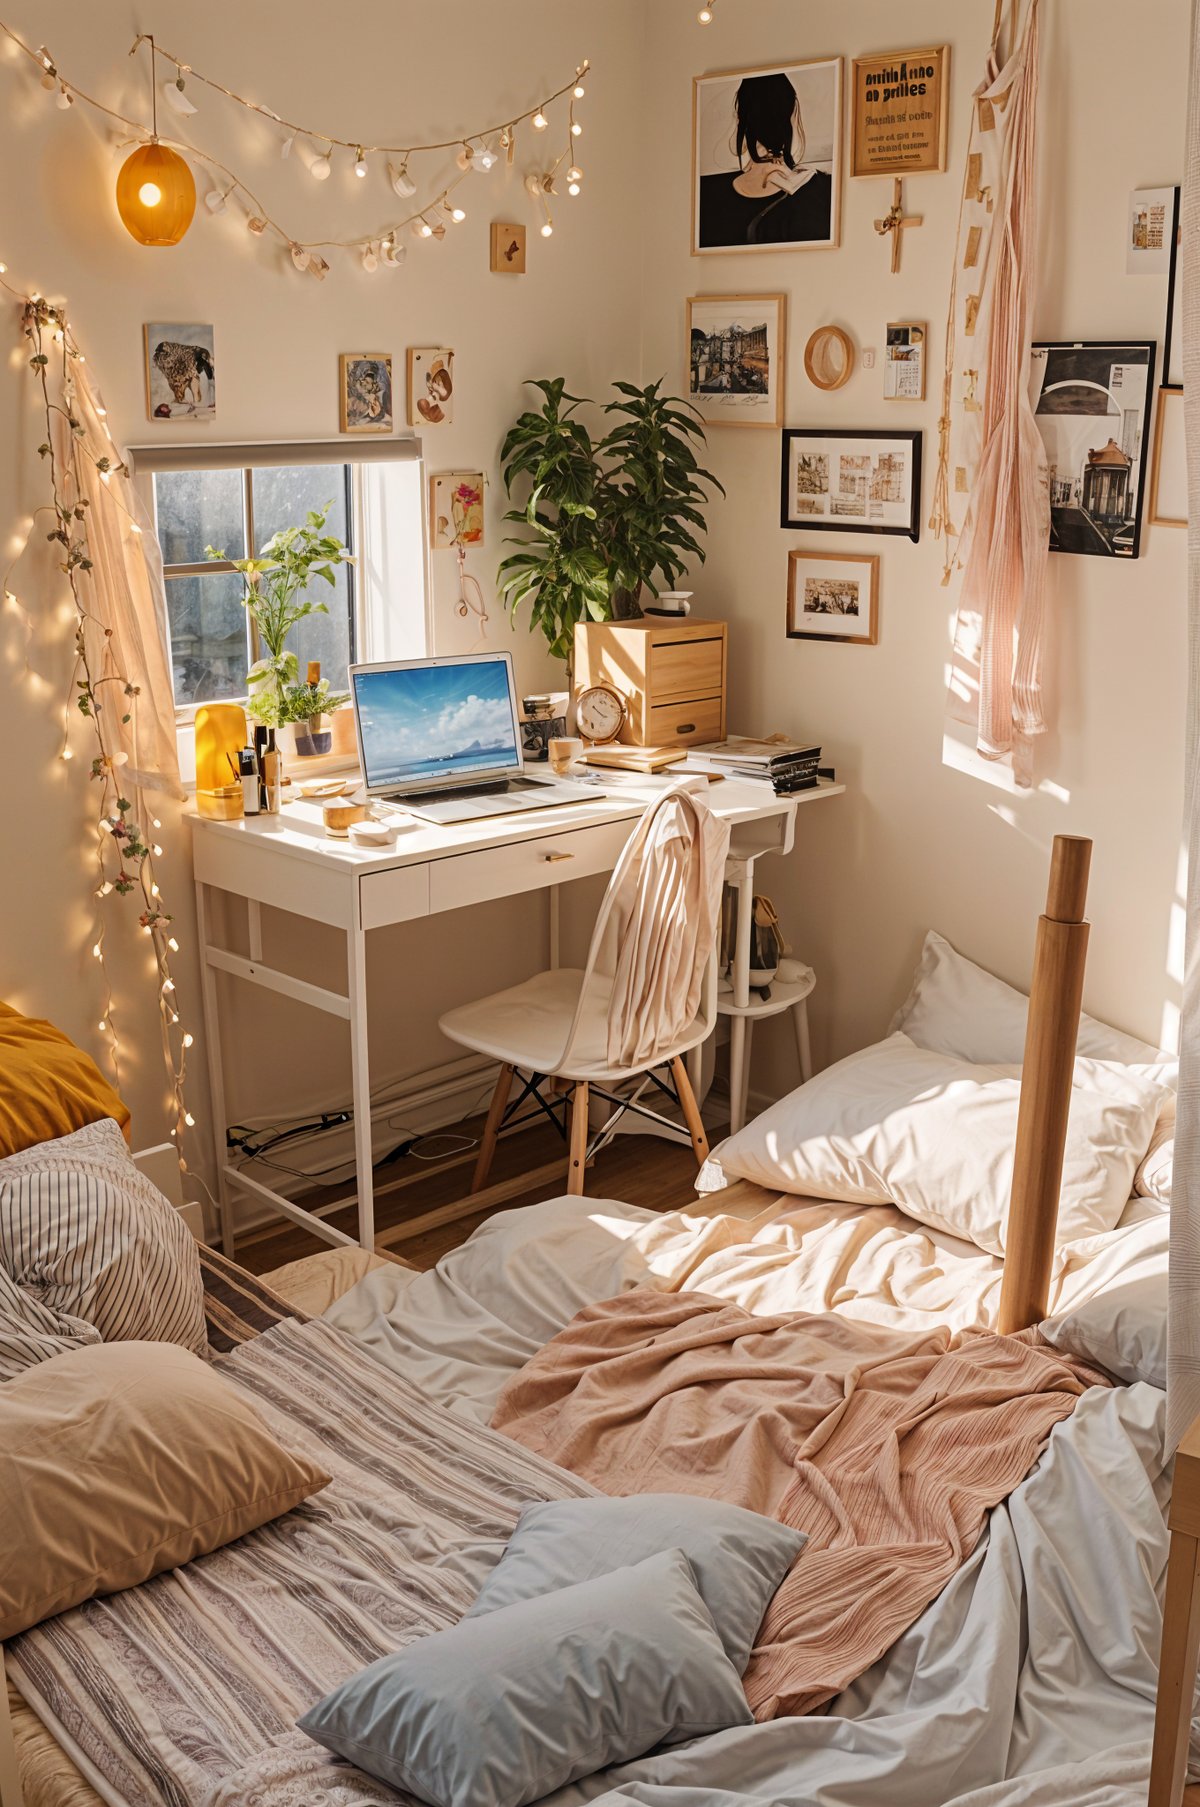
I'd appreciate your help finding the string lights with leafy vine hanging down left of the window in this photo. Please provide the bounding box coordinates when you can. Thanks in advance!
[0,276,193,1167]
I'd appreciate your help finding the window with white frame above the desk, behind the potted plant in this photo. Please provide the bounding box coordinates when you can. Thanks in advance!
[132,439,428,719]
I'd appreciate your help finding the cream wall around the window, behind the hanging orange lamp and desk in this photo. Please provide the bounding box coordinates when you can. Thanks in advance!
[0,0,642,1164]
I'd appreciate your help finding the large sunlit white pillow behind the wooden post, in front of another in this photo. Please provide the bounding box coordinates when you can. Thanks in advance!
[698,1034,1164,1254]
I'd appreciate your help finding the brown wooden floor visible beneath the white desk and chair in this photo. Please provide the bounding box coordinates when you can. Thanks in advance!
[237,1117,696,1274]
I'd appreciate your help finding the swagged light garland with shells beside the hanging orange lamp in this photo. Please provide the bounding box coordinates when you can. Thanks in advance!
[0,20,591,280]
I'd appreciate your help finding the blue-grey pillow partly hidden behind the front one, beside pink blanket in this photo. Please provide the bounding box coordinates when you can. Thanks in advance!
[466,1493,808,1675]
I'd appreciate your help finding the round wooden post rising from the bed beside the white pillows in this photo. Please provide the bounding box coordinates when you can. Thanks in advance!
[998,835,1092,1335]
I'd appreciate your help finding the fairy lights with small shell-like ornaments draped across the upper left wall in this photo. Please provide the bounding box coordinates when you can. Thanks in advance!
[0,20,591,280]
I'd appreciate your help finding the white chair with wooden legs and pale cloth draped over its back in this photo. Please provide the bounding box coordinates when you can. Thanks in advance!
[439,790,728,1193]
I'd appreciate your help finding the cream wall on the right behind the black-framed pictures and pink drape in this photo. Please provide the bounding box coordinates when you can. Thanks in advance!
[643,0,1189,1093]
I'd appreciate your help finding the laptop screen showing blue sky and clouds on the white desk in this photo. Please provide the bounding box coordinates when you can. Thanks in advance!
[351,652,520,790]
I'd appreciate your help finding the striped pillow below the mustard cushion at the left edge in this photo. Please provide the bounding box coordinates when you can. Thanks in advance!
[0,1119,208,1381]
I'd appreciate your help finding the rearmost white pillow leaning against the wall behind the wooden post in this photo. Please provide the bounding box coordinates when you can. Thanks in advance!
[887,929,1178,1088]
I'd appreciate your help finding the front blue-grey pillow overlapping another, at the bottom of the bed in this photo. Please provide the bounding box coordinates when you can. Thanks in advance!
[298,1550,752,1807]
